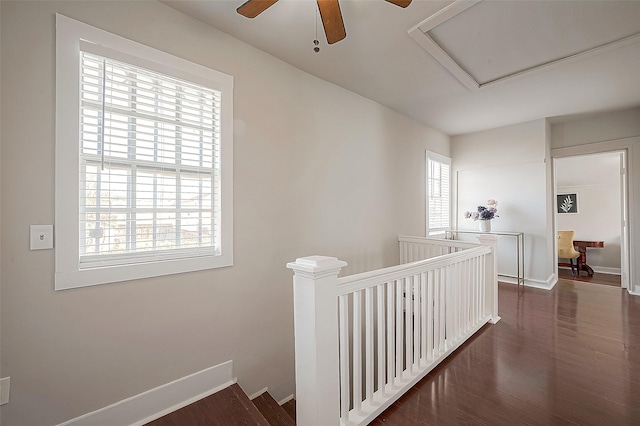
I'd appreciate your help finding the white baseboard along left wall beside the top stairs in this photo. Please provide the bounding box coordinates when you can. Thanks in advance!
[58,361,236,426]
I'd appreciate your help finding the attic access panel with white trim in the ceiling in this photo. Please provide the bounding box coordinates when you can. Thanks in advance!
[408,0,640,90]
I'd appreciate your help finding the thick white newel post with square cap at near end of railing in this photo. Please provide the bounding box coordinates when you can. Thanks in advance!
[287,256,347,426]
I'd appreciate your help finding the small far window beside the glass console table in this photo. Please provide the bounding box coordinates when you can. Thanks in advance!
[427,151,451,235]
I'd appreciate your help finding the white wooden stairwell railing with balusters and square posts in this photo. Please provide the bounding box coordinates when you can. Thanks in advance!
[289,236,499,425]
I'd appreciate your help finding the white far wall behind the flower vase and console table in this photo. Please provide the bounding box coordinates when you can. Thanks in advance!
[451,120,553,287]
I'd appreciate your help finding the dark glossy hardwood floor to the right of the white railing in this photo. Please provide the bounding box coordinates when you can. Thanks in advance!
[371,280,640,426]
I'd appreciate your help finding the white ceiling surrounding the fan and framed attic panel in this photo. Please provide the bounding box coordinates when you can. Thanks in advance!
[163,0,640,135]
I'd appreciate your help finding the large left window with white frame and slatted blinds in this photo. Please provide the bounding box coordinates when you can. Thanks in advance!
[55,15,233,289]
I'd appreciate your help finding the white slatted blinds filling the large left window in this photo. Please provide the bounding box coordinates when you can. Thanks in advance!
[79,52,221,269]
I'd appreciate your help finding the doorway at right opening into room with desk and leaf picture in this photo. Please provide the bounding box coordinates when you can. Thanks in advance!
[553,151,629,288]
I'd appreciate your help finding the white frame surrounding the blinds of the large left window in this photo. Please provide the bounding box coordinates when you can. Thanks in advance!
[55,15,233,290]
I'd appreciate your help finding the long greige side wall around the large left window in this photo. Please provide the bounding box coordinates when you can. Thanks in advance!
[0,1,450,426]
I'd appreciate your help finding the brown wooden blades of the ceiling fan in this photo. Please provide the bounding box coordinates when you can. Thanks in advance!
[236,0,411,44]
